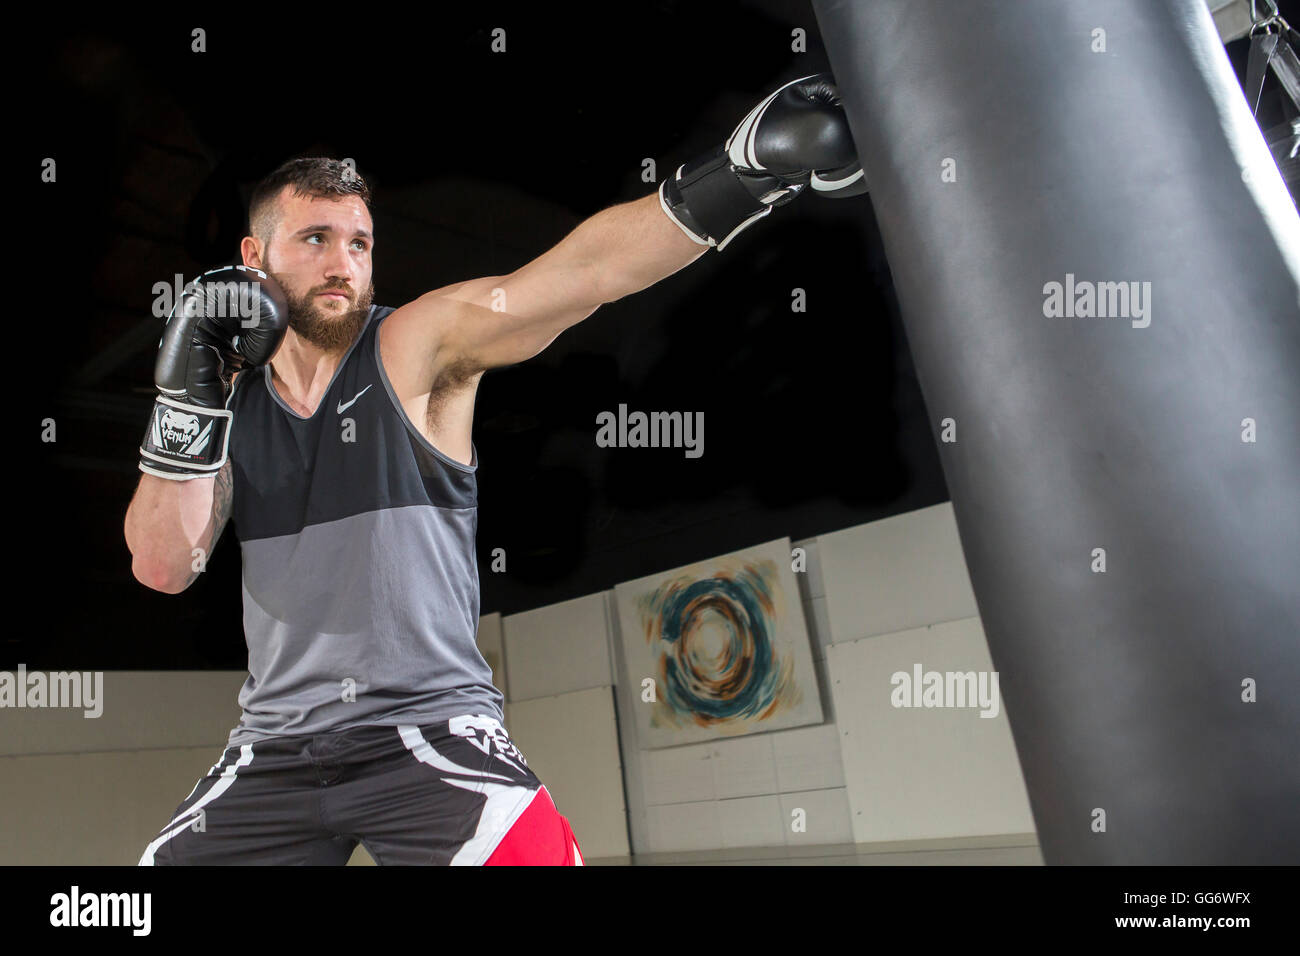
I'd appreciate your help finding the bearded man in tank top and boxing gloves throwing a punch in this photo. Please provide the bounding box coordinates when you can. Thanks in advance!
[126,74,865,865]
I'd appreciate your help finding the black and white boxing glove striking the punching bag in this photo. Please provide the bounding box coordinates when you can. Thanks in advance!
[659,73,867,251]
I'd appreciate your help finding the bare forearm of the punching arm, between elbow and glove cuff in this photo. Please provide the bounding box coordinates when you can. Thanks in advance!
[574,193,709,302]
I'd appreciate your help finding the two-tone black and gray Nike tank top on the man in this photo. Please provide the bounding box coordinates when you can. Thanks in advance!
[220,306,504,747]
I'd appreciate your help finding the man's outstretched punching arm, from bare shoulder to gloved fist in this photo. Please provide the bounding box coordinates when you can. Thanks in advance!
[381,74,866,385]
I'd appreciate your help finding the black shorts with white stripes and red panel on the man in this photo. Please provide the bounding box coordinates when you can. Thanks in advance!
[140,715,582,866]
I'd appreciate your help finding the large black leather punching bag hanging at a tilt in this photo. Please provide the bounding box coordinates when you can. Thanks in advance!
[814,0,1300,864]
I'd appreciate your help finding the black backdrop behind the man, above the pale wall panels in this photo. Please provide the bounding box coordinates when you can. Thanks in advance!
[15,0,1296,670]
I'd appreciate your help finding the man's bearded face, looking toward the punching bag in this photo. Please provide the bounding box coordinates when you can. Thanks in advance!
[252,186,374,351]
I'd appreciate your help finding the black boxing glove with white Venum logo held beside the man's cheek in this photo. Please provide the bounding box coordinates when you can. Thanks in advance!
[140,265,289,481]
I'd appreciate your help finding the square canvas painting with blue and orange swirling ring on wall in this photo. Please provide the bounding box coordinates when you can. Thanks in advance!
[615,538,823,749]
